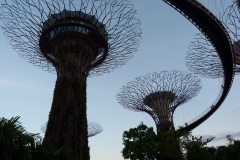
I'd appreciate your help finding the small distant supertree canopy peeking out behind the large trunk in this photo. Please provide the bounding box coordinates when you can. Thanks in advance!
[41,121,103,138]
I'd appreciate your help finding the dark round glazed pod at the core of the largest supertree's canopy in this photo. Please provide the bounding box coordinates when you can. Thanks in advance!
[39,10,110,74]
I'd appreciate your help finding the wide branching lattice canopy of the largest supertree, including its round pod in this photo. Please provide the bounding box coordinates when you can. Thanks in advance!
[0,0,141,75]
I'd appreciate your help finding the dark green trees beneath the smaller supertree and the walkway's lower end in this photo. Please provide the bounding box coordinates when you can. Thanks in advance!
[121,123,222,160]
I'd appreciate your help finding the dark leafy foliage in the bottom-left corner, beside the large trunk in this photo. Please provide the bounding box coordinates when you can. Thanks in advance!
[0,116,73,160]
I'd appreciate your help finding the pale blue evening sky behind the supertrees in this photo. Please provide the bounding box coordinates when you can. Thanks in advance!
[0,0,240,160]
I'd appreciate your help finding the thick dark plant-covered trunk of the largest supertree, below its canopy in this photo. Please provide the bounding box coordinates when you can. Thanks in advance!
[44,73,90,160]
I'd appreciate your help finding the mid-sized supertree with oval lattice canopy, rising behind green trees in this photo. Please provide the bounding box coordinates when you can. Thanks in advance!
[117,71,201,132]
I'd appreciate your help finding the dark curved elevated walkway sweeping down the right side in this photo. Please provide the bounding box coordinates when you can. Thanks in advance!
[163,0,234,130]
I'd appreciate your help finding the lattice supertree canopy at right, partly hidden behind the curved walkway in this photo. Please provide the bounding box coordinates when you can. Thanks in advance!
[185,33,240,78]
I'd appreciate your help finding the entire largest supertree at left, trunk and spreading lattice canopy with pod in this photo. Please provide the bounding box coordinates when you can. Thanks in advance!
[0,0,141,160]
